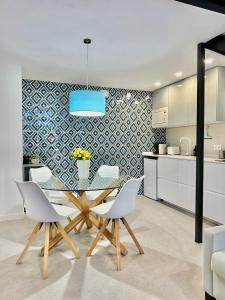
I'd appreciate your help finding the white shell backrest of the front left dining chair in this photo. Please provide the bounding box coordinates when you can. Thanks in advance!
[16,181,60,222]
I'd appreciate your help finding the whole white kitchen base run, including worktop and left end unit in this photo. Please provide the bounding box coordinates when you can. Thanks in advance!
[142,152,225,224]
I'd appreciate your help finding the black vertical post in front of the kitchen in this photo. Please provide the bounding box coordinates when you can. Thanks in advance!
[195,43,205,243]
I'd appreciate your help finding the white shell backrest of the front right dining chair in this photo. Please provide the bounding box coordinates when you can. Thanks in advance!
[105,176,144,219]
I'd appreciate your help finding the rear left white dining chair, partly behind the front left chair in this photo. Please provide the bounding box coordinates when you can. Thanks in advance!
[30,167,68,205]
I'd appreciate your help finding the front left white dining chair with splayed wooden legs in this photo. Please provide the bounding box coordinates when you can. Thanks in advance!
[16,181,80,279]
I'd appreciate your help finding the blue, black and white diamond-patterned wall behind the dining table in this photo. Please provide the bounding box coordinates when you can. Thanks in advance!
[23,80,165,192]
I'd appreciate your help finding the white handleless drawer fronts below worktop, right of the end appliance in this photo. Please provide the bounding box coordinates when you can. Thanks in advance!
[155,157,225,224]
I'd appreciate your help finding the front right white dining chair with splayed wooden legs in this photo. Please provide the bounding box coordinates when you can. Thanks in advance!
[87,176,144,271]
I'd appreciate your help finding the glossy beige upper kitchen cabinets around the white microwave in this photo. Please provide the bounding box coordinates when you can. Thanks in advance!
[153,67,225,127]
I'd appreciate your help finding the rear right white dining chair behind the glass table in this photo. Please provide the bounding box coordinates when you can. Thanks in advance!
[86,165,119,201]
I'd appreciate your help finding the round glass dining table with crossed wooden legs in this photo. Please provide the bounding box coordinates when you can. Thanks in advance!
[37,174,131,255]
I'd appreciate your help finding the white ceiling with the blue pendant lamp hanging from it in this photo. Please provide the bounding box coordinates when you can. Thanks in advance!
[0,0,225,90]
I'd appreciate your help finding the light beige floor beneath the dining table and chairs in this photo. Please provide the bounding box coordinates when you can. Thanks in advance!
[0,196,211,300]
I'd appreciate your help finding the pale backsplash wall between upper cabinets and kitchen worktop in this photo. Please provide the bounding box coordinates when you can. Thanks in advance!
[166,123,225,158]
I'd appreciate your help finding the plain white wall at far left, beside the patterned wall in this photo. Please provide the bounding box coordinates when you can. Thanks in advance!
[0,53,23,221]
